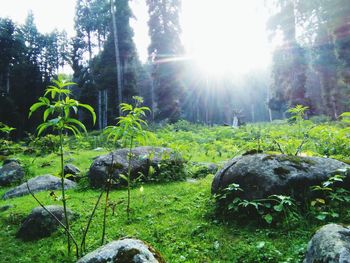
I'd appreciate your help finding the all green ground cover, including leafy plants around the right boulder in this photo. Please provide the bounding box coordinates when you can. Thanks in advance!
[4,121,350,263]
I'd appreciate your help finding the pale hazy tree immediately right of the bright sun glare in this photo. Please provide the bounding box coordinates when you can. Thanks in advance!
[268,0,308,111]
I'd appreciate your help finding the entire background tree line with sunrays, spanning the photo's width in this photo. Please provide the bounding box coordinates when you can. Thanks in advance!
[0,0,350,136]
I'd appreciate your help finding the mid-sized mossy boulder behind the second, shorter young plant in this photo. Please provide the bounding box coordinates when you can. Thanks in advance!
[88,146,184,187]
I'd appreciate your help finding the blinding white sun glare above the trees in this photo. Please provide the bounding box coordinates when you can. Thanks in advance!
[181,0,271,75]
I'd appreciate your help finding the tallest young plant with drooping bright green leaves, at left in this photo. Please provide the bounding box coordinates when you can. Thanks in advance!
[29,76,96,254]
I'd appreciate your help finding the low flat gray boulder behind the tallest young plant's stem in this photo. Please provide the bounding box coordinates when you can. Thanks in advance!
[2,174,77,199]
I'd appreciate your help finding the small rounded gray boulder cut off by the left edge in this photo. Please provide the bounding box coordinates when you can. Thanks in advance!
[0,160,25,186]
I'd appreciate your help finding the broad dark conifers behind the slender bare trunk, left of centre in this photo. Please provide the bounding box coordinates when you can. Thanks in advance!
[72,0,140,129]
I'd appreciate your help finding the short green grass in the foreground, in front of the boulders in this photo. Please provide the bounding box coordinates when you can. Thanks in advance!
[0,176,310,262]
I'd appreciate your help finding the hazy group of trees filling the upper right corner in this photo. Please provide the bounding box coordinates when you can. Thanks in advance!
[268,0,350,119]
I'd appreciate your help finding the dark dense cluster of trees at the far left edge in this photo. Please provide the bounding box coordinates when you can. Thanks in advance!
[0,13,69,137]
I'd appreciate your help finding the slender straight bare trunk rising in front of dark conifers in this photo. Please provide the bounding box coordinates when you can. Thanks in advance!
[110,0,123,116]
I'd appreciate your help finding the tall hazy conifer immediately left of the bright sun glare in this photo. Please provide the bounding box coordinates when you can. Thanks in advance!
[147,0,183,122]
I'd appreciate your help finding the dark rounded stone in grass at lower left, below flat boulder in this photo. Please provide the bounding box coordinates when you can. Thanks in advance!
[16,205,74,241]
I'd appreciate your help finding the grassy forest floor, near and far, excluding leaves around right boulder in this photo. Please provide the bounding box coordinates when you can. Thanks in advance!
[0,121,350,263]
